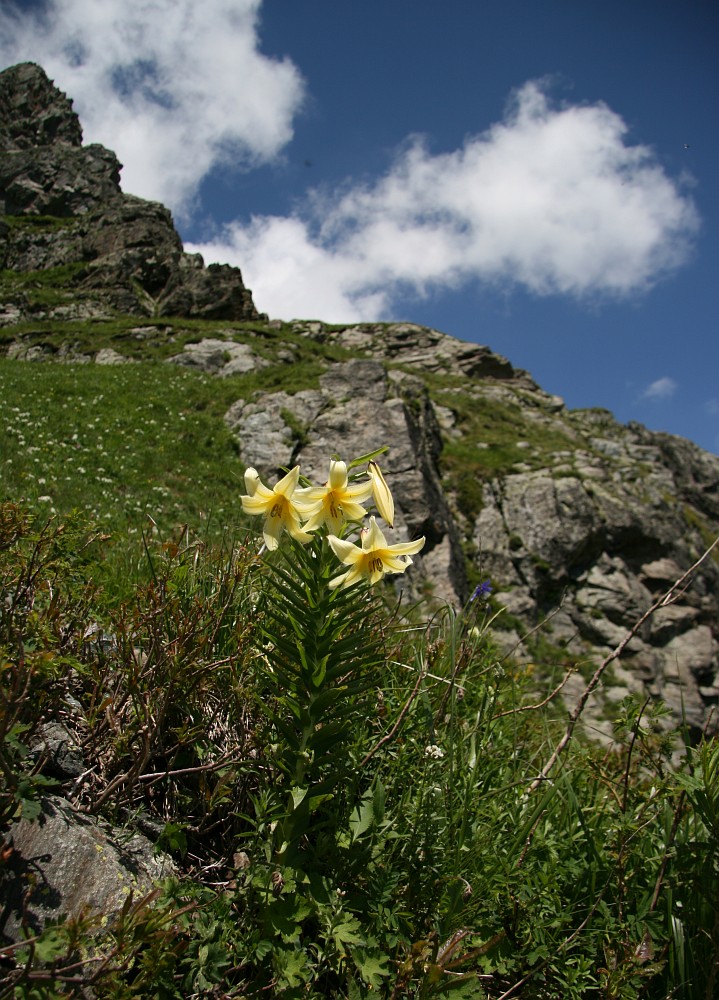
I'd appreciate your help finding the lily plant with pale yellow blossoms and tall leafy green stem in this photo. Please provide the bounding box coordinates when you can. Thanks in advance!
[236,452,425,873]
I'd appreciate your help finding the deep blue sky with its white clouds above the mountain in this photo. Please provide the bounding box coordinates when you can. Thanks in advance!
[0,0,719,452]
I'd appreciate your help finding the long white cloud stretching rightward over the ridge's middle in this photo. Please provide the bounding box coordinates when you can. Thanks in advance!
[188,81,698,320]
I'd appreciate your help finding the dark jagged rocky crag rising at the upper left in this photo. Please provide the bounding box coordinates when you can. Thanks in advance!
[0,63,258,322]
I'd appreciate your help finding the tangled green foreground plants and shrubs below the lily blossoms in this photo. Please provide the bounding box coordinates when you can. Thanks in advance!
[0,480,719,1000]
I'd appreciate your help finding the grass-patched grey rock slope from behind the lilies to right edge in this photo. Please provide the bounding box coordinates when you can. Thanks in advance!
[226,322,719,734]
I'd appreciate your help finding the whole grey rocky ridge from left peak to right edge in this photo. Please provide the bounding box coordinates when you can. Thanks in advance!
[0,65,719,735]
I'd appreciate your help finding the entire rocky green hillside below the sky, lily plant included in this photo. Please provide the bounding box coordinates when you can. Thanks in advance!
[0,64,719,1000]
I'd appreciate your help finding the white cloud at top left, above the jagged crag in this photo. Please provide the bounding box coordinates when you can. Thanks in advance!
[0,0,304,213]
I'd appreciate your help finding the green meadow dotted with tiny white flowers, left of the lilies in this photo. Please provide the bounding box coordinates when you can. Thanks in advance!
[0,360,248,532]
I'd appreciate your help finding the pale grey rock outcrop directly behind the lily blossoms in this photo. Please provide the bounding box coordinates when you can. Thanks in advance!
[225,360,467,603]
